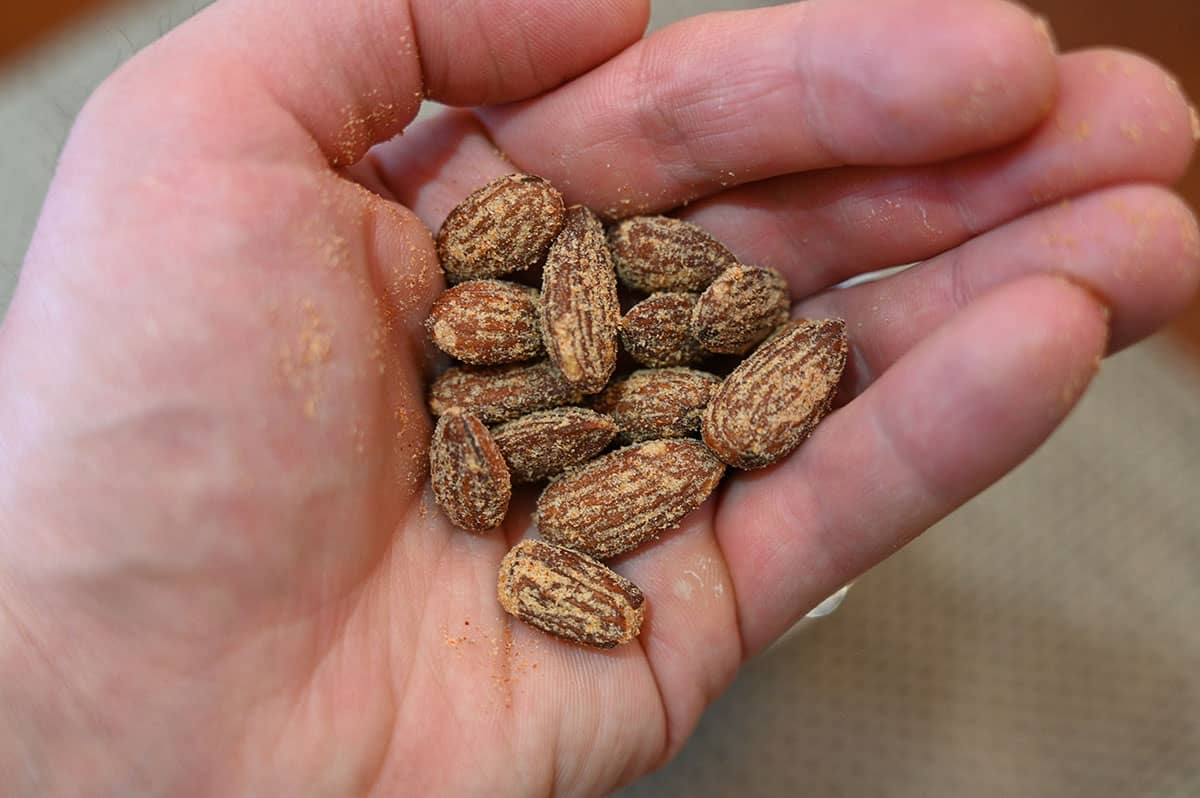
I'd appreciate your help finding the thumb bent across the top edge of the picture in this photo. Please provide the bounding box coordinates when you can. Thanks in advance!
[87,0,649,164]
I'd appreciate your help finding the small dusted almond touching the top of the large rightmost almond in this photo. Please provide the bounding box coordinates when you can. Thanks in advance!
[691,265,792,355]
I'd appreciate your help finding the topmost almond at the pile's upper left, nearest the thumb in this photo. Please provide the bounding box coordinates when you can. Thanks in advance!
[438,174,564,282]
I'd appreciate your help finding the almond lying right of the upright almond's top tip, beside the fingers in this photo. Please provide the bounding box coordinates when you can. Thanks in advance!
[608,216,737,294]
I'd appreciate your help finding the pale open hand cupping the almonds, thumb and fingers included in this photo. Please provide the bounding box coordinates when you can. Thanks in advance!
[0,0,1200,796]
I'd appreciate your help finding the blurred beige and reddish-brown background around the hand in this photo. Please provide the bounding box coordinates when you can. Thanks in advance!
[0,0,1200,798]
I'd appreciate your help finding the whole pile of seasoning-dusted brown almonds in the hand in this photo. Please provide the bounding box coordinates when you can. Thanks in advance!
[426,174,847,648]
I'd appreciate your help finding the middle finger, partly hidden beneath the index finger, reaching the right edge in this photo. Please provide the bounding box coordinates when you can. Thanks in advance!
[680,50,1196,296]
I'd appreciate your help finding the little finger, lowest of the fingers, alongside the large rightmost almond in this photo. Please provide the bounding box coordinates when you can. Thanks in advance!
[715,276,1106,653]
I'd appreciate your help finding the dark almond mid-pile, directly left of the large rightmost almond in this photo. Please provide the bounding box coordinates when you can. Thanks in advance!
[592,368,721,443]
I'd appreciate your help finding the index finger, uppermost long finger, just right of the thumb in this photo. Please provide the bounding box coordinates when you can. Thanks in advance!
[472,0,1056,216]
